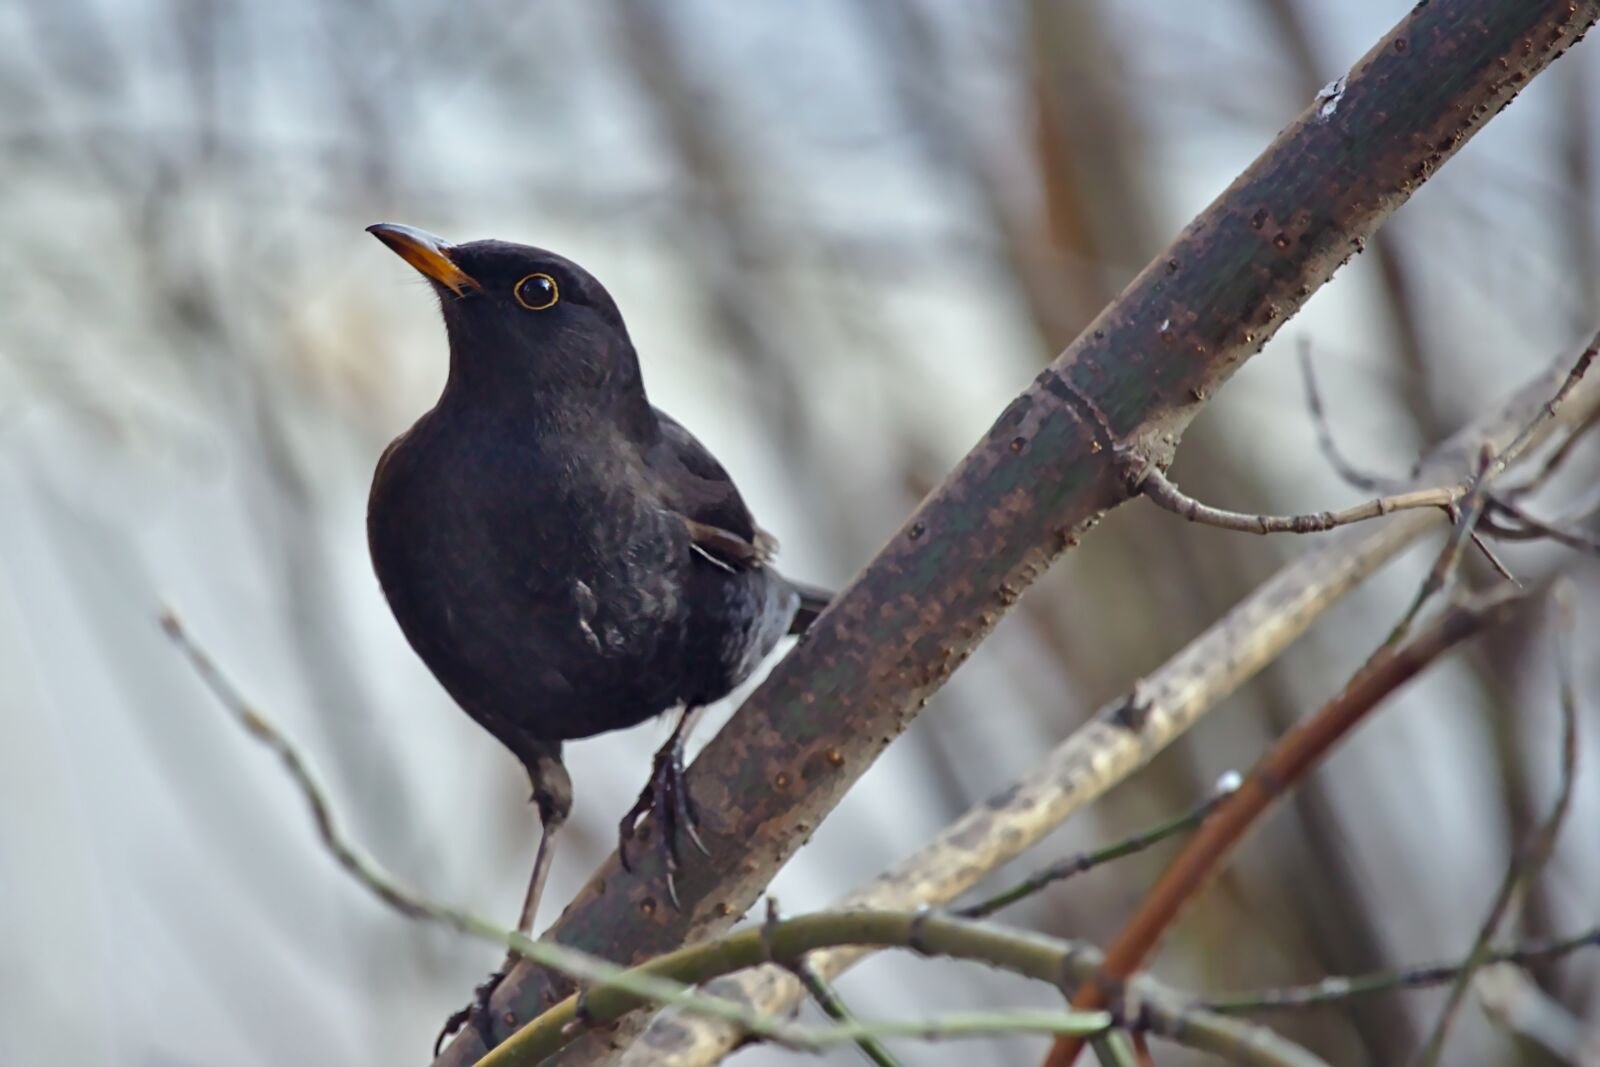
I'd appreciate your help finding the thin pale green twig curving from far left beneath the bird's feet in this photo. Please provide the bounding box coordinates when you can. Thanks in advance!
[160,609,1139,1067]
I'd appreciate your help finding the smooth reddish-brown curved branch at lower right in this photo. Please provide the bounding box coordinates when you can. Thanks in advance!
[1046,592,1525,1067]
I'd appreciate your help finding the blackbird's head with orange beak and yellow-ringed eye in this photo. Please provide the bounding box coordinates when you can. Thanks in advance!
[366,222,643,406]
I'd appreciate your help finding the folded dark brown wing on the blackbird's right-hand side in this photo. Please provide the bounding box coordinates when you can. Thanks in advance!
[645,411,778,571]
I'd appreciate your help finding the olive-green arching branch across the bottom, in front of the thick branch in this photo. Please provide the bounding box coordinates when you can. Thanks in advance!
[480,910,1323,1067]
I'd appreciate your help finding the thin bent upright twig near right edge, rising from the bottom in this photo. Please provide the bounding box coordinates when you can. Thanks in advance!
[1416,582,1578,1067]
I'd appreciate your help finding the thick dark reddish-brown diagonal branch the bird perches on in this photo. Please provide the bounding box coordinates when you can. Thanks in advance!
[437,0,1600,1065]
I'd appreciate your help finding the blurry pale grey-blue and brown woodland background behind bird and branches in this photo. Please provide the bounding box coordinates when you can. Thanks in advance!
[0,0,1600,1067]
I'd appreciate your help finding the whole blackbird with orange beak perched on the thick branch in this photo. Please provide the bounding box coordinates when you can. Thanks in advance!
[366,224,827,1045]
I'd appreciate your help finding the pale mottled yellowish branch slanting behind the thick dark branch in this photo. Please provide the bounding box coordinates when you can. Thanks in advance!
[629,347,1600,1067]
